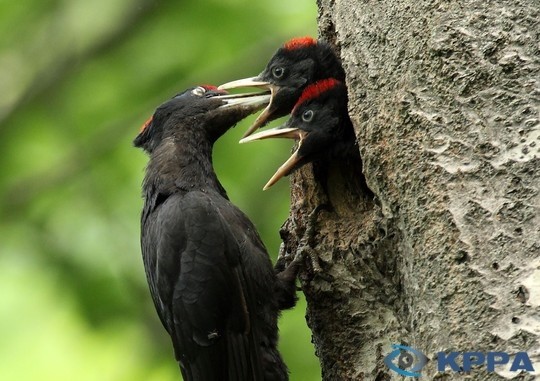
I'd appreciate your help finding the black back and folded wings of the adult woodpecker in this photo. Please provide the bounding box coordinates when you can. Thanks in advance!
[142,192,271,381]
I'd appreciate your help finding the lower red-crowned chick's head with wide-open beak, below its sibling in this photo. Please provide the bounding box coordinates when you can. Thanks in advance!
[240,78,355,190]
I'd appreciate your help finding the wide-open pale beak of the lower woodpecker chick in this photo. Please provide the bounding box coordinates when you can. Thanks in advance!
[240,126,308,190]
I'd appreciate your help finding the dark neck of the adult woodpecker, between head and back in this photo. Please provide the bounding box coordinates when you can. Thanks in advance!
[145,136,227,198]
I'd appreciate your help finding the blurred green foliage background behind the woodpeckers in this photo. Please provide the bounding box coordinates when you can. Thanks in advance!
[0,0,320,381]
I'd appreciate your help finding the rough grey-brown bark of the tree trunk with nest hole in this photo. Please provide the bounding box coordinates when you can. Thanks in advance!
[282,0,540,381]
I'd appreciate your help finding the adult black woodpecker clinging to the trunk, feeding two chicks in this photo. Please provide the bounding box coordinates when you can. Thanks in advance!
[134,86,296,381]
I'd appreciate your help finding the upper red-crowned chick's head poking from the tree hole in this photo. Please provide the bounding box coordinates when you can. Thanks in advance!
[219,37,345,137]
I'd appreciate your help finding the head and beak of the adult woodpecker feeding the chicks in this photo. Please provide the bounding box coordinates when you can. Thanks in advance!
[133,85,270,153]
